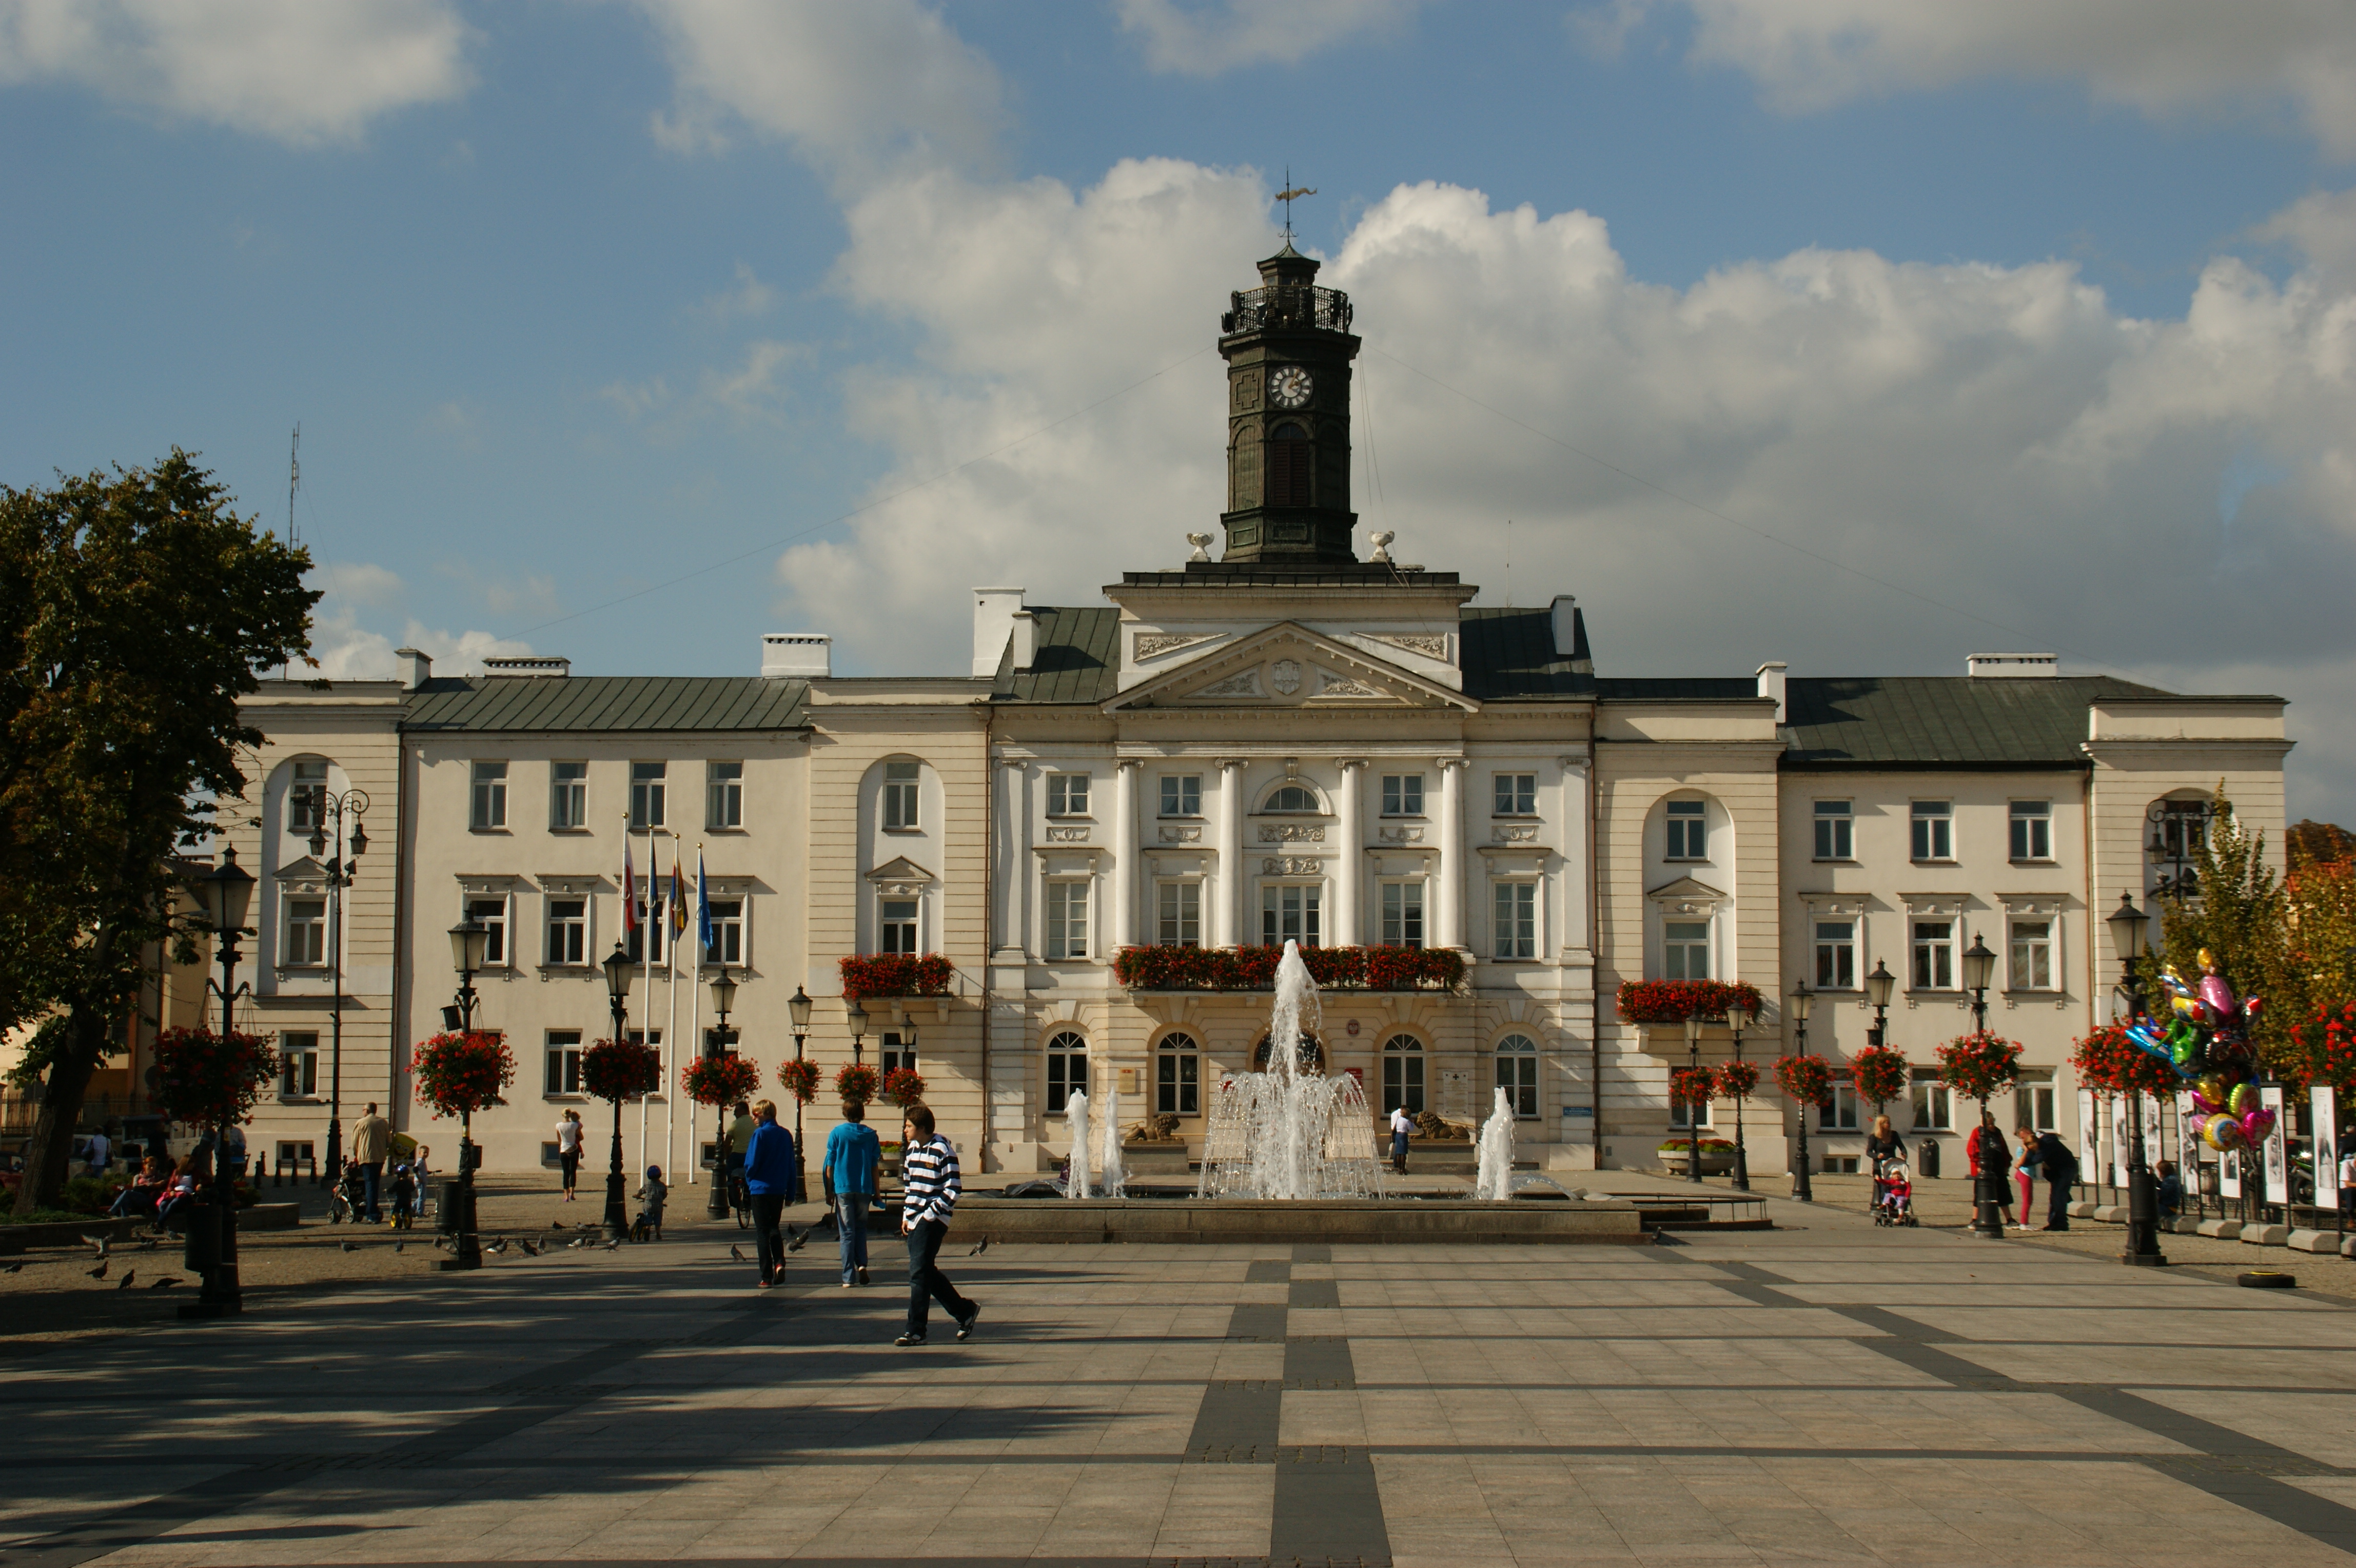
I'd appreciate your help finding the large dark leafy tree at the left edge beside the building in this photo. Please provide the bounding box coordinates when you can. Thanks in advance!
[0,447,318,1212]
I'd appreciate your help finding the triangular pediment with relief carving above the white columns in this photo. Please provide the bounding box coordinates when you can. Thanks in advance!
[1105,621,1480,713]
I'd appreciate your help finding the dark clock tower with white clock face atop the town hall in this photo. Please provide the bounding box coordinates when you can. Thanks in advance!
[1218,240,1357,565]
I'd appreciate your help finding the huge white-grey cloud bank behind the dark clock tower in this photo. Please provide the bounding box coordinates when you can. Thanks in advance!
[777,160,2356,810]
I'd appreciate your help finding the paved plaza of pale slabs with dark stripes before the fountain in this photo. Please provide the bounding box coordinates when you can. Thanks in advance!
[13,1186,2356,1568]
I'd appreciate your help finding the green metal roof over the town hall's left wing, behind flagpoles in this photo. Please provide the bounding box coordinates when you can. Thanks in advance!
[403,676,811,730]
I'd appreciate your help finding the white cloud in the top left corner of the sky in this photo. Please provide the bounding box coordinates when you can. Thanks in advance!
[0,0,469,146]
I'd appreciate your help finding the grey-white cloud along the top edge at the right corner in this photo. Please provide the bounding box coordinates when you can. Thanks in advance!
[1630,0,2356,155]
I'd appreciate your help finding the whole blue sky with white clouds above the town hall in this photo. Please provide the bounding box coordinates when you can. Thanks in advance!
[13,0,2356,821]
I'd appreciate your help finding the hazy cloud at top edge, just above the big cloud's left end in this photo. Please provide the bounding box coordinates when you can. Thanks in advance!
[638,0,1004,177]
